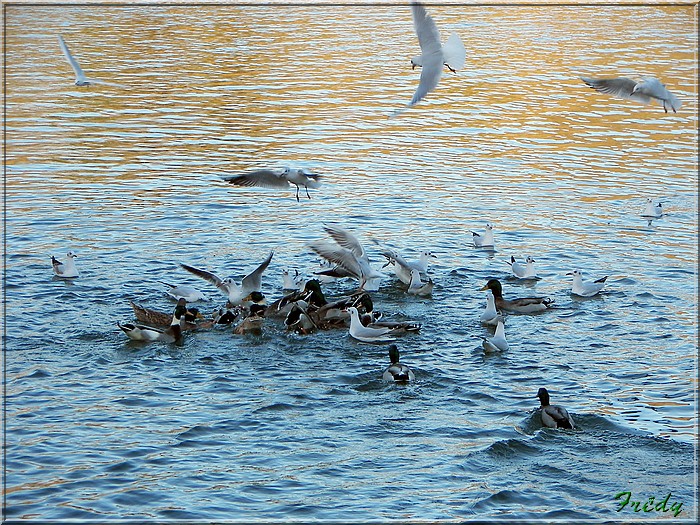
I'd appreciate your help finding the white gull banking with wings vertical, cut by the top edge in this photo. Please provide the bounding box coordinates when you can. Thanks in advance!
[392,2,466,116]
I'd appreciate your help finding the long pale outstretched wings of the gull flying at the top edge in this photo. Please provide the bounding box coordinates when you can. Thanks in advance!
[408,3,443,107]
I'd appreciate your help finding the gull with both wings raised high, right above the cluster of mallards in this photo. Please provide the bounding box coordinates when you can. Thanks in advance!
[309,226,385,292]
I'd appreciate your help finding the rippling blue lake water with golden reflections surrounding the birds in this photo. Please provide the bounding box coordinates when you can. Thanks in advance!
[4,5,698,522]
